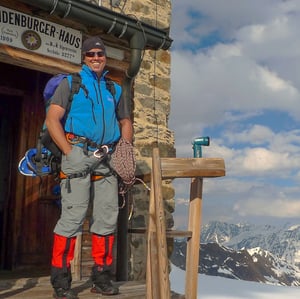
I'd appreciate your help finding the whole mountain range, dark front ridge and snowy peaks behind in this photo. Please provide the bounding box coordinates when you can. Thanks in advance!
[171,221,300,286]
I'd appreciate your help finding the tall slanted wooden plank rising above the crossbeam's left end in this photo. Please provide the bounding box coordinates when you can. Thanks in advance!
[152,148,170,298]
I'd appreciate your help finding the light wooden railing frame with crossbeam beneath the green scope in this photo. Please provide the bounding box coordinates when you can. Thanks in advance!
[146,148,225,299]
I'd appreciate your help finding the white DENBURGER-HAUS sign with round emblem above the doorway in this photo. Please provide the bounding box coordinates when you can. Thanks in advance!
[0,6,82,64]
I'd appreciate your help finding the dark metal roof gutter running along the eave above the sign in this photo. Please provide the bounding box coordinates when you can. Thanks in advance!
[20,0,173,50]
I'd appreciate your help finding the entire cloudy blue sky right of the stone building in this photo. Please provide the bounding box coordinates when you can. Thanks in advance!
[169,0,300,229]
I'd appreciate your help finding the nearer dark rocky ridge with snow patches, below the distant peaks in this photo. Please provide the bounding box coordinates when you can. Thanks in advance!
[171,240,300,286]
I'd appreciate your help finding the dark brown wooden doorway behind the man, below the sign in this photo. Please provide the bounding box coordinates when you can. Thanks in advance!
[0,63,60,269]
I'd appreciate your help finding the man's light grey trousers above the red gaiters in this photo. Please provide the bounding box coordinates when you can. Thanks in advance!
[54,146,119,238]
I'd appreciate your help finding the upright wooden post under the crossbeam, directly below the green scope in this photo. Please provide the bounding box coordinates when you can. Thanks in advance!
[185,178,203,299]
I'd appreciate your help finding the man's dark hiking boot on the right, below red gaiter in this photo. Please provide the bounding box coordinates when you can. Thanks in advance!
[91,266,119,295]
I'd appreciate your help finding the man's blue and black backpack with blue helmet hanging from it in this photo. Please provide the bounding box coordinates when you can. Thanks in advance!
[18,73,117,177]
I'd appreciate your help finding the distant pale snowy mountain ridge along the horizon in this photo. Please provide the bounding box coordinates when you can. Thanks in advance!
[201,221,300,267]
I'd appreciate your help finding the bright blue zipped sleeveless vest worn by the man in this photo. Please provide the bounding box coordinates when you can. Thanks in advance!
[65,65,122,145]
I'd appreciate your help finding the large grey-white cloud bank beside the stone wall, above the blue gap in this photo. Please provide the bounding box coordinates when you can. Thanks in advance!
[170,38,300,134]
